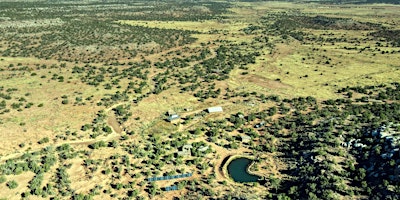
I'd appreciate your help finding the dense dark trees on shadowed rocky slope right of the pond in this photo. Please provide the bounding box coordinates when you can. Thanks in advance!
[255,84,400,199]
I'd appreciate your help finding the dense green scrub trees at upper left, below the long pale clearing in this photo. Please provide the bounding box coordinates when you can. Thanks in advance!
[0,5,195,63]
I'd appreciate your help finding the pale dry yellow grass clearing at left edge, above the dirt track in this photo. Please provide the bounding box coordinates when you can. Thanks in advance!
[0,59,104,154]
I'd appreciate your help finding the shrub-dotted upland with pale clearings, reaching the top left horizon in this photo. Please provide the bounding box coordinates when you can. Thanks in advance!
[0,1,229,63]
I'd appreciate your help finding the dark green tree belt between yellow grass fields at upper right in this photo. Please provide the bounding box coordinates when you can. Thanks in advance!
[258,12,392,47]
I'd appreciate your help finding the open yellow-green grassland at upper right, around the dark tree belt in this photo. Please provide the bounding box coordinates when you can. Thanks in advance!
[228,2,400,99]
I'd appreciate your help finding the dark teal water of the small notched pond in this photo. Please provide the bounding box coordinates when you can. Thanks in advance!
[228,158,260,183]
